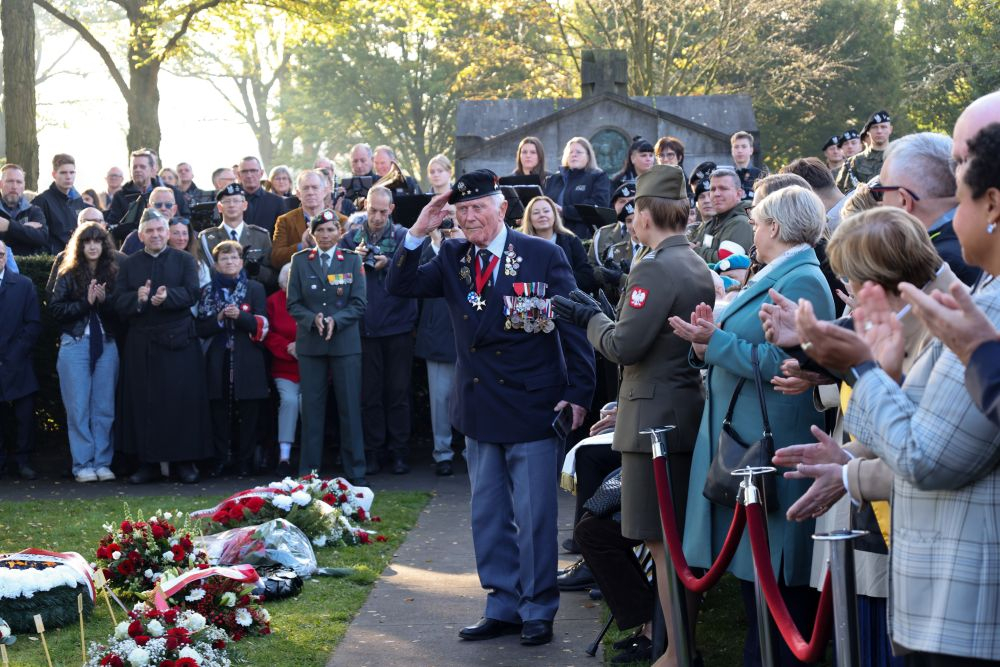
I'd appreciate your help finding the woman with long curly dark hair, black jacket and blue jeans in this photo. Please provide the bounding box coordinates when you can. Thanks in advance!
[49,222,118,482]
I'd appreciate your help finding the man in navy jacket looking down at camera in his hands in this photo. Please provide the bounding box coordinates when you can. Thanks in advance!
[340,186,417,475]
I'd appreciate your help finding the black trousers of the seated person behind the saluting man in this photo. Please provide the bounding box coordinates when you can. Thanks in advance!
[573,512,654,630]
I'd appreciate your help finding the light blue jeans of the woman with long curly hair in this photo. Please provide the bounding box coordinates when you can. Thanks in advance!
[56,334,118,475]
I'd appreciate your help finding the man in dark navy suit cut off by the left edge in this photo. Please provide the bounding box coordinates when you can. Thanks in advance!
[0,241,42,480]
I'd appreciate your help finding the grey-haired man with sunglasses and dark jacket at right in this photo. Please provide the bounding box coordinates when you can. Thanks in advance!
[872,132,982,285]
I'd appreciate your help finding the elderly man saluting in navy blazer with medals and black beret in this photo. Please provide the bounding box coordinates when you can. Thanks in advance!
[387,170,594,645]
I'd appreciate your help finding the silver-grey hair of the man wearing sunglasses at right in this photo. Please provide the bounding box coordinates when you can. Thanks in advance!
[883,132,956,198]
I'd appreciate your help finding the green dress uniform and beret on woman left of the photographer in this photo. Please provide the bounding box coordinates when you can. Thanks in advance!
[288,217,367,481]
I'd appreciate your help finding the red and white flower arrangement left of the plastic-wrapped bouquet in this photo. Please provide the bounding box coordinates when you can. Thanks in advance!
[96,504,208,600]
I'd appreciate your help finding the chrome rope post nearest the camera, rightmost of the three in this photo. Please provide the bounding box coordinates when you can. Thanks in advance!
[813,530,868,667]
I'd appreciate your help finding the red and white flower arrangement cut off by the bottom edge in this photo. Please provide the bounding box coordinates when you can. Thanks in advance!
[86,603,232,667]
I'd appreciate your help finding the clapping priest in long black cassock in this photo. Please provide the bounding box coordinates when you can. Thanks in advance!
[114,210,211,484]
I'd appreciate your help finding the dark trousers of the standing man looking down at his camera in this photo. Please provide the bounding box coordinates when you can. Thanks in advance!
[361,332,413,460]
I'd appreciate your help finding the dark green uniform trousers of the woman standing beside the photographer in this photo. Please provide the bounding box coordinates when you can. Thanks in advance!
[299,354,365,480]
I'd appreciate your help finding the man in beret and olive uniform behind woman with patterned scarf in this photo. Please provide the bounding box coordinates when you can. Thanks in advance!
[198,183,277,292]
